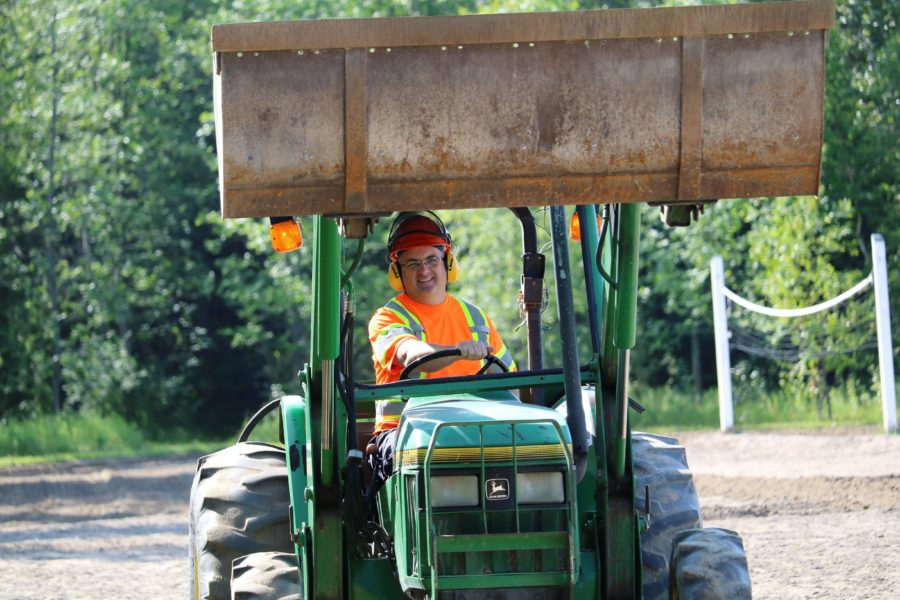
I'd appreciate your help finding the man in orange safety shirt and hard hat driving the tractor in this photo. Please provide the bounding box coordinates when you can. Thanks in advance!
[367,211,516,480]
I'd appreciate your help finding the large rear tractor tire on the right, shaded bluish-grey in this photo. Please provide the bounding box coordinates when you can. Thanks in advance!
[631,432,703,600]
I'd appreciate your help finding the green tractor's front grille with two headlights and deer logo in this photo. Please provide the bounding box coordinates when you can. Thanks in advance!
[415,421,578,600]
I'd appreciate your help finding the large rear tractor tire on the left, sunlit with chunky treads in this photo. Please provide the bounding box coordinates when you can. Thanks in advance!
[189,442,293,600]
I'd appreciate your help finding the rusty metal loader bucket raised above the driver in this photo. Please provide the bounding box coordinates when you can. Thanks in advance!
[212,0,834,217]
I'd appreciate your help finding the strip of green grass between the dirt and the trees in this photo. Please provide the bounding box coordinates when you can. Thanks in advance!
[0,388,882,468]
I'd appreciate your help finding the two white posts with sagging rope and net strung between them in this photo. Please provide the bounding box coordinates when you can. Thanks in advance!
[710,234,898,432]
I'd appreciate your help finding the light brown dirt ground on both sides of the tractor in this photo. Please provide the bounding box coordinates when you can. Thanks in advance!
[0,430,900,600]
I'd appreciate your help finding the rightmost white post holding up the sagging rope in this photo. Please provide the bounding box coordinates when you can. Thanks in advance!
[872,233,897,433]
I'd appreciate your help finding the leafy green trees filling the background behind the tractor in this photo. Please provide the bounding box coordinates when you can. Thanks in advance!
[0,0,900,437]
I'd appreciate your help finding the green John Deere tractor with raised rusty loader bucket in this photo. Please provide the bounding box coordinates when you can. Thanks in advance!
[190,0,834,600]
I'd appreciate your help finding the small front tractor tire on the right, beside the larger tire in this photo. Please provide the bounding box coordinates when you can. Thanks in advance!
[670,527,752,600]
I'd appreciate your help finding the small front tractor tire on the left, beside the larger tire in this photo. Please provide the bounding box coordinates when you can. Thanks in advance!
[231,552,303,600]
